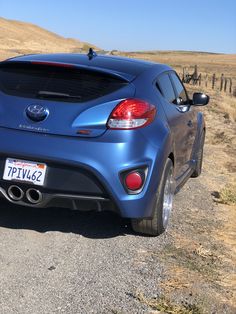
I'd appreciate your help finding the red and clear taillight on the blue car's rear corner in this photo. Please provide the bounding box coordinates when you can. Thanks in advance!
[107,98,156,130]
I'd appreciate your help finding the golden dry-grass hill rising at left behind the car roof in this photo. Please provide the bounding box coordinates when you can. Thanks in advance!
[0,17,97,59]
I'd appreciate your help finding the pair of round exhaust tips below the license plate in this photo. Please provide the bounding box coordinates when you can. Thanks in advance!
[7,185,43,204]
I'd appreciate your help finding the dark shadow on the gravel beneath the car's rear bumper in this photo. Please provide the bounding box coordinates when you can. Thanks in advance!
[0,200,133,239]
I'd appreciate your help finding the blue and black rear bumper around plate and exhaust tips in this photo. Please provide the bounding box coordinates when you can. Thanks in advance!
[0,128,168,218]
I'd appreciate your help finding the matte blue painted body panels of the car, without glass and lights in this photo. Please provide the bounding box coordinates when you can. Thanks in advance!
[0,54,204,218]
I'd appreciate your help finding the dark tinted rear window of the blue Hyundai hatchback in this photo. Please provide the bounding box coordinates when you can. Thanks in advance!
[0,62,127,102]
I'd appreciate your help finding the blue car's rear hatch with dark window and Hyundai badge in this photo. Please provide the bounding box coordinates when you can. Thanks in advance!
[0,61,135,137]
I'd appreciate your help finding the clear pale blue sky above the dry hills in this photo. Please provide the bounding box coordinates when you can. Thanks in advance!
[0,0,236,53]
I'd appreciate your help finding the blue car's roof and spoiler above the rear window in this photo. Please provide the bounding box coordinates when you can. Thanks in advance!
[3,53,171,81]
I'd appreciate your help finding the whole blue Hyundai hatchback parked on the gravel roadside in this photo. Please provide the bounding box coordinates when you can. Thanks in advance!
[0,50,209,236]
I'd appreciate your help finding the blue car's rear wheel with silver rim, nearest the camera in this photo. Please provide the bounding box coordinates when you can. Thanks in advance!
[131,158,174,236]
